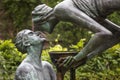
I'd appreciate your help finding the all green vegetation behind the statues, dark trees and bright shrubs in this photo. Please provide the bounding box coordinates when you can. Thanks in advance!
[0,0,120,80]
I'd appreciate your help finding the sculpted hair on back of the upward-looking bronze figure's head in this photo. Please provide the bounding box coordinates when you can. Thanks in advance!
[15,29,27,53]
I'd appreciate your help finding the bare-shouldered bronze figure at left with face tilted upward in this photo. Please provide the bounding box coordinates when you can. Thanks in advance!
[15,29,56,80]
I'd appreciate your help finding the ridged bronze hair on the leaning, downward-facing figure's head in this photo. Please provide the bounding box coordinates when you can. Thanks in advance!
[32,4,53,23]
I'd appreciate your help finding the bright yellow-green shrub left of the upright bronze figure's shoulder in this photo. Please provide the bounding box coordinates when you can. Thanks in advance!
[0,40,25,80]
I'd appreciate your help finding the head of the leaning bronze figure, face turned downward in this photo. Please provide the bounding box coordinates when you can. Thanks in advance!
[32,4,52,33]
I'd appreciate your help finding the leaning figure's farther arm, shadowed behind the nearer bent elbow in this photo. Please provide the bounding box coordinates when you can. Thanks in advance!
[87,19,120,58]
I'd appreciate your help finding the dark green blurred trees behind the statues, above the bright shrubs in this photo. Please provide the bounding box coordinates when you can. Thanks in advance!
[0,0,120,47]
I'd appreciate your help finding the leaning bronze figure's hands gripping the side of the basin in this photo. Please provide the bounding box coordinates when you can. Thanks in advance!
[57,56,87,73]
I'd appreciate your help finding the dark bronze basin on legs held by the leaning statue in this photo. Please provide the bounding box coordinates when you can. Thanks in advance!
[49,51,85,80]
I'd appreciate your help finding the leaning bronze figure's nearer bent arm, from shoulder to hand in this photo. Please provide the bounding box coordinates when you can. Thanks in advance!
[55,0,113,68]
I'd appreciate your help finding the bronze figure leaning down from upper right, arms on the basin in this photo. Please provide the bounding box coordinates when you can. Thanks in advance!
[15,0,120,79]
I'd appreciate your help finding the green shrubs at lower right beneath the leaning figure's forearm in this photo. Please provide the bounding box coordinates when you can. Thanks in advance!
[76,44,120,80]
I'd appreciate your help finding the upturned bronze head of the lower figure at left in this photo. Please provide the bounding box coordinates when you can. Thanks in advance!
[15,29,45,53]
